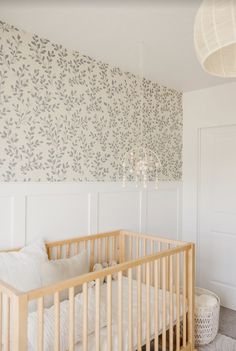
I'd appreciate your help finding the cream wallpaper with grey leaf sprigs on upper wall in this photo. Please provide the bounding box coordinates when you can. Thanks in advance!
[0,22,182,182]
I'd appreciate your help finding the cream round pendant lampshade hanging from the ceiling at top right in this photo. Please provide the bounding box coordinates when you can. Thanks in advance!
[194,0,236,77]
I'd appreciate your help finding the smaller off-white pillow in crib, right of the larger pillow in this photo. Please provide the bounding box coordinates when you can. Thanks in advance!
[41,250,89,307]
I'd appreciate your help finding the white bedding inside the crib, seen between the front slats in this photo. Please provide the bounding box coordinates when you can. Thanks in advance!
[28,277,182,351]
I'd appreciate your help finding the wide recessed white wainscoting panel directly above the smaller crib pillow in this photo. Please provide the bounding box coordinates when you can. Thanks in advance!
[26,193,90,242]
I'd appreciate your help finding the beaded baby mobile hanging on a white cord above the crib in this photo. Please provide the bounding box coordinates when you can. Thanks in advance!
[122,44,161,189]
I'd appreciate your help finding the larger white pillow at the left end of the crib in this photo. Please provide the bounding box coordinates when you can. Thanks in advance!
[0,240,48,292]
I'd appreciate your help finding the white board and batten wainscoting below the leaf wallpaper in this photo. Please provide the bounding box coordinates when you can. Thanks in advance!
[0,182,182,249]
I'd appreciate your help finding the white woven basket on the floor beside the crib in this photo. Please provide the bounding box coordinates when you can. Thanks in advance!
[195,288,220,346]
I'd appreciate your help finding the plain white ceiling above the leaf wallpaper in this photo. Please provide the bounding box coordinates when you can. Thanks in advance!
[0,0,235,91]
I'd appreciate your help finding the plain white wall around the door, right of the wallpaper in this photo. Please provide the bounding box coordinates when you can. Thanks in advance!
[183,83,236,280]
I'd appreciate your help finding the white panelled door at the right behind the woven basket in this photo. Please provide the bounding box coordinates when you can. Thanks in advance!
[198,126,236,310]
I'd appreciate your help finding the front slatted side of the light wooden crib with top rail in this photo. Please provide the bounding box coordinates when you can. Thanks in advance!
[22,244,194,351]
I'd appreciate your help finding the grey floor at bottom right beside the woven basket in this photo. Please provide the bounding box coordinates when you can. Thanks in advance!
[198,307,236,351]
